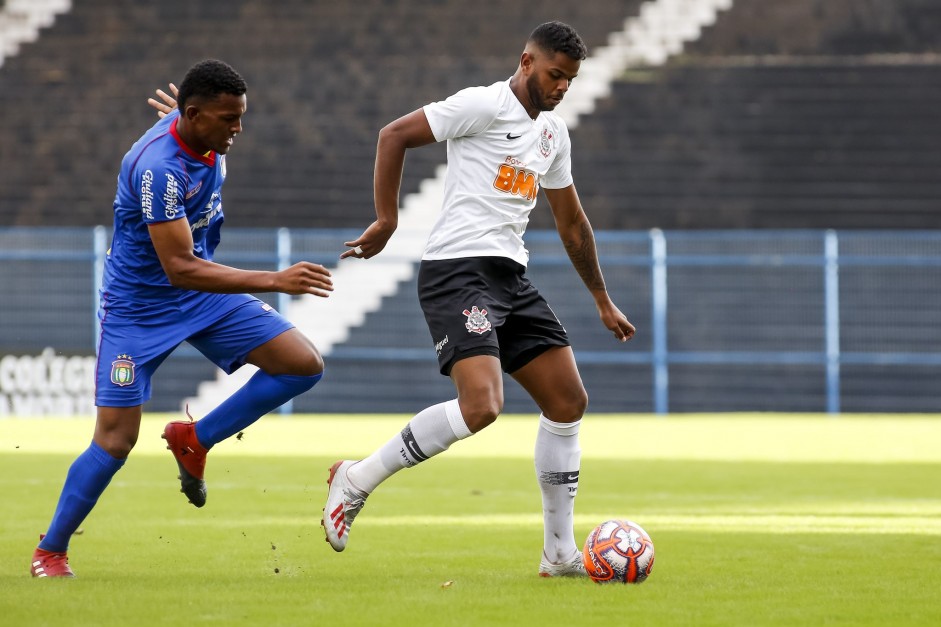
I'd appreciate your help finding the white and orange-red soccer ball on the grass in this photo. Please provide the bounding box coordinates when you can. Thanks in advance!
[582,520,653,583]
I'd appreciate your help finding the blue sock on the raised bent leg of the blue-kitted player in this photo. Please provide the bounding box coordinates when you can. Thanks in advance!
[196,370,323,449]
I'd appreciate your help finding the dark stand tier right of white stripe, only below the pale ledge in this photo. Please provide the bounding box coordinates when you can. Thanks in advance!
[534,58,941,229]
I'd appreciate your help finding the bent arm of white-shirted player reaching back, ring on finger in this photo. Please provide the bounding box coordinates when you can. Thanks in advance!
[340,109,436,259]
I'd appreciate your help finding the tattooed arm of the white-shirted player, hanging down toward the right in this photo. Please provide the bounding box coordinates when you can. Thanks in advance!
[543,185,635,342]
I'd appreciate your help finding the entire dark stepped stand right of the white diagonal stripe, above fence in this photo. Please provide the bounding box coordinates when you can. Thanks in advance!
[533,0,941,229]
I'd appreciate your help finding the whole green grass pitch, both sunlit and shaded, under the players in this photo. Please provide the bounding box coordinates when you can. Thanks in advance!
[0,415,941,626]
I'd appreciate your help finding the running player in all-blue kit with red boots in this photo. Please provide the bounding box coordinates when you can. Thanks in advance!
[30,60,333,577]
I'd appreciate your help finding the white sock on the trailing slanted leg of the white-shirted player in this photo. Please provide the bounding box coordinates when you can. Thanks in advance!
[347,398,471,494]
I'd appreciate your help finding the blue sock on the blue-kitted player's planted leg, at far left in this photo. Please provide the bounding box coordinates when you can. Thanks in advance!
[39,442,126,552]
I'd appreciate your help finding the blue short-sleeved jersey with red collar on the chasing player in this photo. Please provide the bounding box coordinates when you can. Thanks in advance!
[102,111,225,315]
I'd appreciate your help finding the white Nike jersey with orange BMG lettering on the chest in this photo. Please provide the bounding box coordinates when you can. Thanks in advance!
[422,81,572,266]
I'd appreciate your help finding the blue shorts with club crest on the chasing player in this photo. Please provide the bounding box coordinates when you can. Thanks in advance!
[95,292,294,407]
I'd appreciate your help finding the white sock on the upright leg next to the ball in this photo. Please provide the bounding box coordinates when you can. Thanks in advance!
[536,415,582,564]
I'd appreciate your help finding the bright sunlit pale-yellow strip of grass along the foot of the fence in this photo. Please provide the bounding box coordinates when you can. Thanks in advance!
[9,414,941,466]
